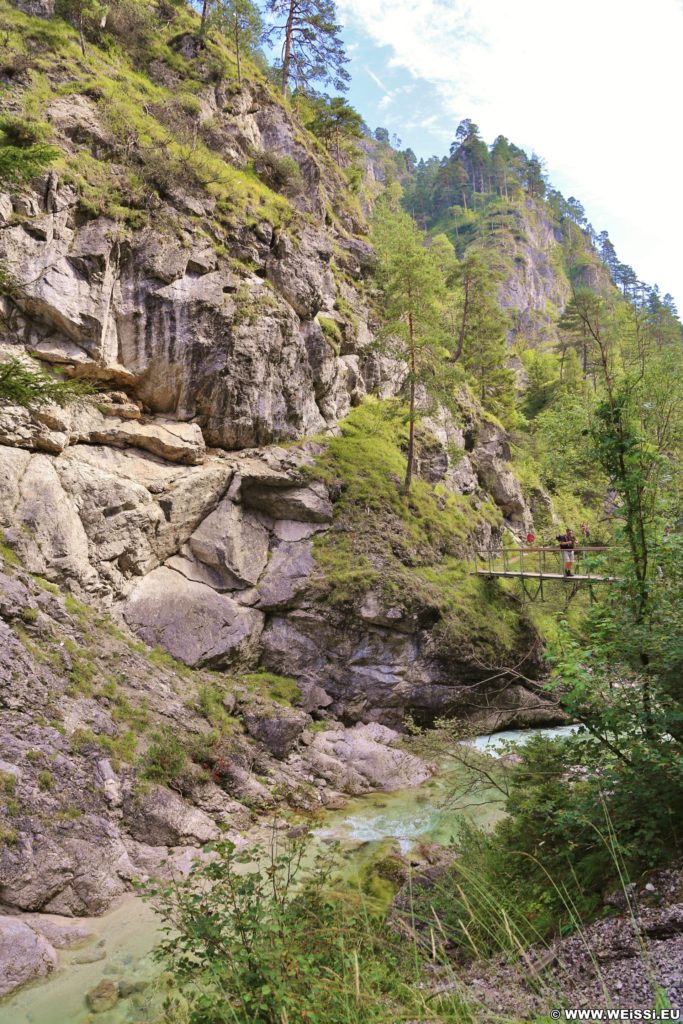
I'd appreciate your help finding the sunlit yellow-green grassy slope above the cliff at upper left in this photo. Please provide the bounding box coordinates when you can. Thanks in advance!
[0,0,294,227]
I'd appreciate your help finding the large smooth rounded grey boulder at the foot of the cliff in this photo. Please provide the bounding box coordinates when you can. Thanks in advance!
[124,566,263,667]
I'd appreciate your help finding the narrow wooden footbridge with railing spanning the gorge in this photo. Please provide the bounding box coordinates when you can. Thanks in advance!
[470,545,622,600]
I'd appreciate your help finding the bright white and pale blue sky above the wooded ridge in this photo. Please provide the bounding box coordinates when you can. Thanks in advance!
[337,0,683,311]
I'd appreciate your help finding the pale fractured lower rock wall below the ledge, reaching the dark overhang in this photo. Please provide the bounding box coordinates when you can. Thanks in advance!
[0,385,543,728]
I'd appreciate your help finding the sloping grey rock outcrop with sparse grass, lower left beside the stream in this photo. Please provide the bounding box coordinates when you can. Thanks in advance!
[0,564,436,937]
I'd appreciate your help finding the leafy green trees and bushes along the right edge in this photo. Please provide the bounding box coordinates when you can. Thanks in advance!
[444,278,683,952]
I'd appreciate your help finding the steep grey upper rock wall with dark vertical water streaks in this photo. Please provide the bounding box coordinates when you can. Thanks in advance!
[0,78,386,449]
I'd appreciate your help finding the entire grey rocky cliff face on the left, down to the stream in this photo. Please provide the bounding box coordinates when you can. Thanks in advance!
[0,0,565,954]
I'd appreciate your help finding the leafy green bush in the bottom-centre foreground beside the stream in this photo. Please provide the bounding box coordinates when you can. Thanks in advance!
[146,841,470,1024]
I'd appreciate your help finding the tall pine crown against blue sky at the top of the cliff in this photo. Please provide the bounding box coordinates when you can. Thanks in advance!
[267,0,349,95]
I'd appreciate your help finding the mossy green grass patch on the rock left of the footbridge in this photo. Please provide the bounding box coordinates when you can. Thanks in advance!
[312,399,530,655]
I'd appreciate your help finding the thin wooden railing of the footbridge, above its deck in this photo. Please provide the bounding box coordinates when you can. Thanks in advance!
[474,545,610,580]
